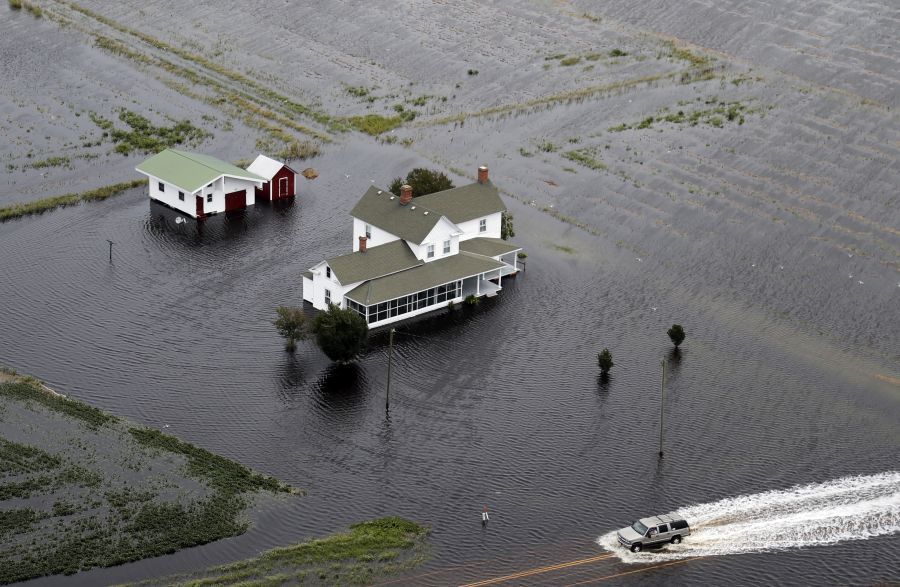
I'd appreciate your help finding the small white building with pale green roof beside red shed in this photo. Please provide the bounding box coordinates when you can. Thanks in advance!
[135,149,265,218]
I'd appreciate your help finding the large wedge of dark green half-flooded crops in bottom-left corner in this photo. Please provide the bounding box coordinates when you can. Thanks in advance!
[0,376,292,584]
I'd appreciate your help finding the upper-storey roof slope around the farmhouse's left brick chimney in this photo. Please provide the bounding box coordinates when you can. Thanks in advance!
[350,186,441,244]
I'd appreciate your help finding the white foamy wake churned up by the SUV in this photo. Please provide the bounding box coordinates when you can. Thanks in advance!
[597,471,900,563]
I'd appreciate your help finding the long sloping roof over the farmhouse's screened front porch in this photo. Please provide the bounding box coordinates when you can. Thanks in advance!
[344,254,505,306]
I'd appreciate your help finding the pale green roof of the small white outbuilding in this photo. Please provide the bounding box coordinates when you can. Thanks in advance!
[135,149,265,192]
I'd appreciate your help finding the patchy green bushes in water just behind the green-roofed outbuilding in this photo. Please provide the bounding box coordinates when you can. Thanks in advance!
[90,108,212,155]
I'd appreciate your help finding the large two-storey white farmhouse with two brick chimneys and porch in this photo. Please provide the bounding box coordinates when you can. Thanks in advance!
[303,167,521,327]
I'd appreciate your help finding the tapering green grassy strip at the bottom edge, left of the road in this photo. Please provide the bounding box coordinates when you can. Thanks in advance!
[151,517,428,587]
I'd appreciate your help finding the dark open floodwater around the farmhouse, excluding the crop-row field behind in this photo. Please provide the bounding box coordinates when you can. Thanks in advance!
[0,140,900,585]
